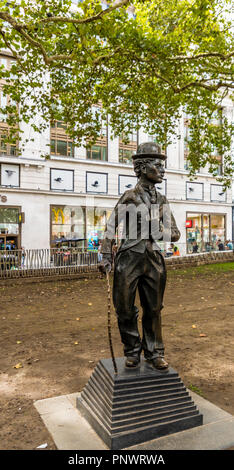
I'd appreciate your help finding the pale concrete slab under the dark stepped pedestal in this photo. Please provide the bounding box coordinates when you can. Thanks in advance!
[34,392,234,450]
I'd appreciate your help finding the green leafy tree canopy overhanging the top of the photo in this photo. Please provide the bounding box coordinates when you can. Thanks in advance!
[0,0,234,186]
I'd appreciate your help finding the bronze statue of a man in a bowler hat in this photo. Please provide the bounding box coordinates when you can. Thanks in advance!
[100,142,180,369]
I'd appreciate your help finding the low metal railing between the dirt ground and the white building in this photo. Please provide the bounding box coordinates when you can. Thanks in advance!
[0,243,234,279]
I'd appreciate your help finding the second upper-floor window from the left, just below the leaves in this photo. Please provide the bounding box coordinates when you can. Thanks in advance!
[50,121,74,157]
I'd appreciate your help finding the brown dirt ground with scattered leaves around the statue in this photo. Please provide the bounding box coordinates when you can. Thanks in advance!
[0,263,234,450]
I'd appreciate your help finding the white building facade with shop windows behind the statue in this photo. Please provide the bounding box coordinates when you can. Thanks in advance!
[0,97,233,254]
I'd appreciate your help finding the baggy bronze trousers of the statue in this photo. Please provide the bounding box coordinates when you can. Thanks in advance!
[113,249,166,359]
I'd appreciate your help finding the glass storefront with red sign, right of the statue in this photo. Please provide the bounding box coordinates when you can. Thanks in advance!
[186,213,226,253]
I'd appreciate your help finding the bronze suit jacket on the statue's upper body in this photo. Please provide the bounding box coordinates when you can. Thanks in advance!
[101,183,180,254]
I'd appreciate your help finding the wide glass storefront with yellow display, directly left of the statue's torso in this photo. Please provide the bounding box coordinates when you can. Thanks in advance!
[51,206,112,250]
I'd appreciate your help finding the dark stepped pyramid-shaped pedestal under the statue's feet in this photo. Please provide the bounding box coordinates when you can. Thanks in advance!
[77,358,203,450]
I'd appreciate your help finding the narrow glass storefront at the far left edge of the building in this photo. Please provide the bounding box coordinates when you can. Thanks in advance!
[0,207,20,251]
